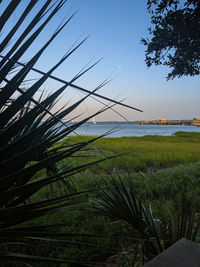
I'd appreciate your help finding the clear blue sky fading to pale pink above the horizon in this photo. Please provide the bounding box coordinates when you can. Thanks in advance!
[1,0,200,121]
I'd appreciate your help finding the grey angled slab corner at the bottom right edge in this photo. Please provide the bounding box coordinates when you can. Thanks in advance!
[144,238,200,267]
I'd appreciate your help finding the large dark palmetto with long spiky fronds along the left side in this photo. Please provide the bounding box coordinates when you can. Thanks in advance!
[0,0,141,262]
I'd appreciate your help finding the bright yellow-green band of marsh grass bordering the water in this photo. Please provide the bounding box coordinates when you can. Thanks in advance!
[63,132,200,174]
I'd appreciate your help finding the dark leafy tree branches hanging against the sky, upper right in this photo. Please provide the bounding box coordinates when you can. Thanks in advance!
[141,0,200,80]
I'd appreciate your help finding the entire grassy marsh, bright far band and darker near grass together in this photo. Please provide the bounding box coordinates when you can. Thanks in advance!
[28,132,200,266]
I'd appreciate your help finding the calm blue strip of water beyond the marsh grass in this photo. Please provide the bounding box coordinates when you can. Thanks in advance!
[67,122,200,137]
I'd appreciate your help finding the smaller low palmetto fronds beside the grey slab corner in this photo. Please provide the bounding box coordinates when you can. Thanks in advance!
[94,177,200,266]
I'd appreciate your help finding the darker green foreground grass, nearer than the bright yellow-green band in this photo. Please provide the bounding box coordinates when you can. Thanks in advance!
[28,163,200,263]
